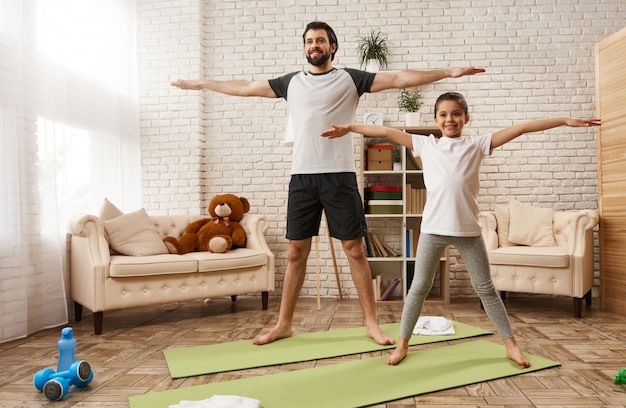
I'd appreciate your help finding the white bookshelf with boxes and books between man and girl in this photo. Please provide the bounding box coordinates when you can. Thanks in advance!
[359,127,450,305]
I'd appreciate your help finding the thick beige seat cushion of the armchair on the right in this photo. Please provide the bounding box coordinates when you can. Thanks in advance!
[488,246,570,268]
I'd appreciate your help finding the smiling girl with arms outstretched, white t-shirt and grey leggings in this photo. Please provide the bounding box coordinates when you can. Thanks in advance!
[321,92,600,368]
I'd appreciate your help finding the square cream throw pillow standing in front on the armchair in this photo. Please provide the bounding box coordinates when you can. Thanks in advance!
[509,200,556,247]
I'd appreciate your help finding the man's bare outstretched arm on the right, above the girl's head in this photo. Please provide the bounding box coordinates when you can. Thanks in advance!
[370,66,485,92]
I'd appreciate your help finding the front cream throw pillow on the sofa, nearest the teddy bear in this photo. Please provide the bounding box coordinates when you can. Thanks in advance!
[104,208,169,256]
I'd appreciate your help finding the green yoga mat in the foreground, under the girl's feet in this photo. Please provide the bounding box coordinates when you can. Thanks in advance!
[129,340,560,408]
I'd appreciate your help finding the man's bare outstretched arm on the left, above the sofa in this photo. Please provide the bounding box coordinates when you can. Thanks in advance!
[171,79,276,98]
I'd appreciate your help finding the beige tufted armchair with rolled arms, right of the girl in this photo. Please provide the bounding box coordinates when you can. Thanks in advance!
[480,204,599,317]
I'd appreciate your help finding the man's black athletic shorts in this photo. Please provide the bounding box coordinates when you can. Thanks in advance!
[286,173,367,240]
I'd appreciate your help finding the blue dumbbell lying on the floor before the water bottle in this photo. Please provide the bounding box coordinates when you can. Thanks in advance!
[33,361,93,401]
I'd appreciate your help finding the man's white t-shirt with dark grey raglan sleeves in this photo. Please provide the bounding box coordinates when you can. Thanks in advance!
[269,68,376,174]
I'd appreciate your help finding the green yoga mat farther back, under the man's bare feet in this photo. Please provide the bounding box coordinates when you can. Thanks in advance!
[163,321,492,378]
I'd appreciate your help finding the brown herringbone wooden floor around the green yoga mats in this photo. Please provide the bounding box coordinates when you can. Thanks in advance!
[0,296,626,408]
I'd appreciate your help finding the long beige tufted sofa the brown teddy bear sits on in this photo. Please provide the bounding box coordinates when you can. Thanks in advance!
[68,213,274,334]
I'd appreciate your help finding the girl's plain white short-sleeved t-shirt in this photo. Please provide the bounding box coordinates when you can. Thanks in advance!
[412,134,491,237]
